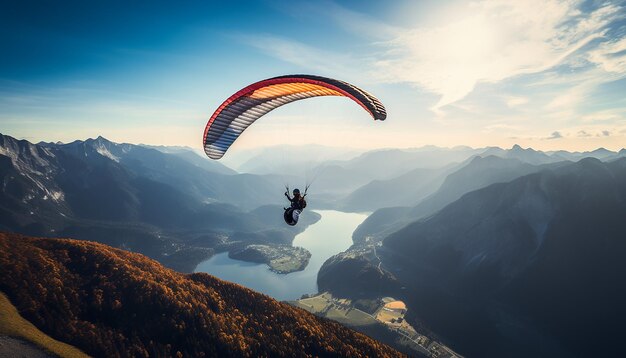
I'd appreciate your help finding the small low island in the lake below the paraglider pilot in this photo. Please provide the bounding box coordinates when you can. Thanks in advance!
[228,244,311,274]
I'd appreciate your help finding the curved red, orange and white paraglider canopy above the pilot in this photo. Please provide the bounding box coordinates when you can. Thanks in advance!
[203,75,387,159]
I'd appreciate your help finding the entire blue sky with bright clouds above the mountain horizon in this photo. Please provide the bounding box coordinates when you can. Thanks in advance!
[0,0,626,151]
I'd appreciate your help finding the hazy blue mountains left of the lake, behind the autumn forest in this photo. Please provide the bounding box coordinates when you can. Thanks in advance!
[0,135,319,271]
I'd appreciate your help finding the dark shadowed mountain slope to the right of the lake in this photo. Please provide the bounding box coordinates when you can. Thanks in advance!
[318,158,626,357]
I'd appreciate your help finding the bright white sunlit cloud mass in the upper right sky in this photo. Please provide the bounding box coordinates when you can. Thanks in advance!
[376,0,621,111]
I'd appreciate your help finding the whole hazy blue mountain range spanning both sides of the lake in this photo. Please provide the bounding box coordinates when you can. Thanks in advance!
[0,135,626,356]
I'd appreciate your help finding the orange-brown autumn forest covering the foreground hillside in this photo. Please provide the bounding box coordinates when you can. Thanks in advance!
[0,233,400,357]
